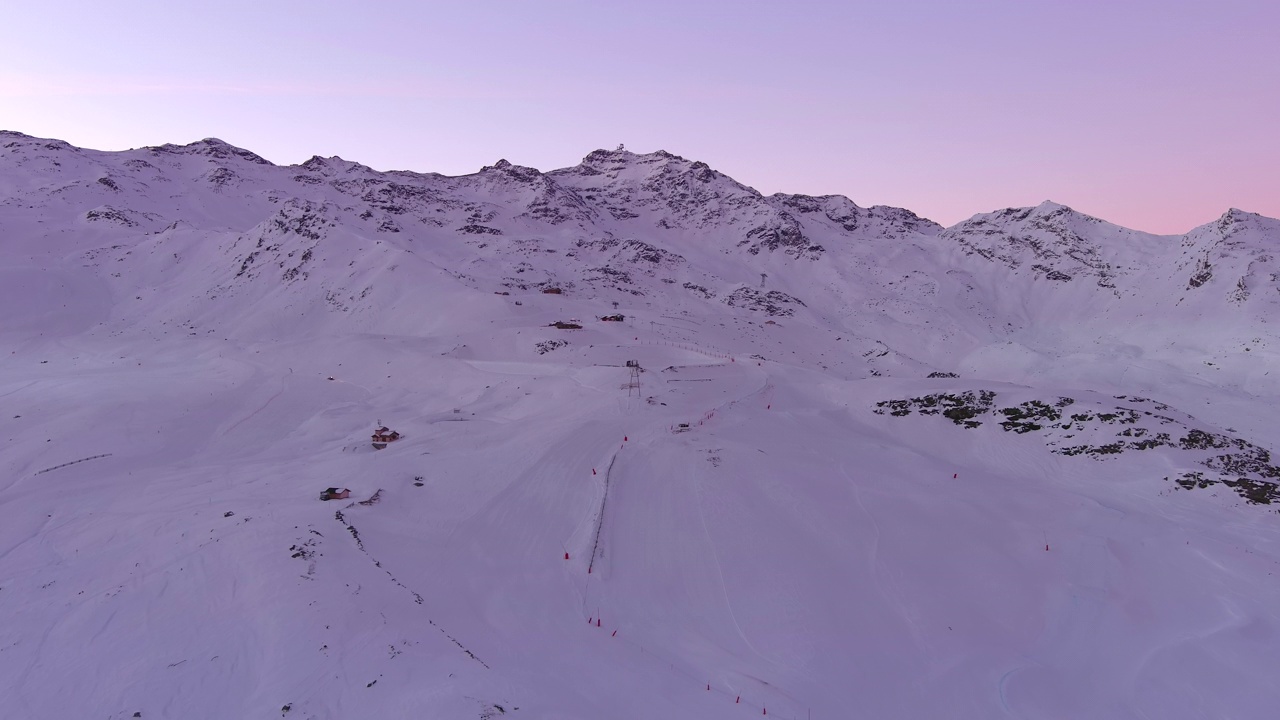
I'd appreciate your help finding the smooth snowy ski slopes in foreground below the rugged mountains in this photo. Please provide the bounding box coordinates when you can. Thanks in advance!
[0,319,1280,720]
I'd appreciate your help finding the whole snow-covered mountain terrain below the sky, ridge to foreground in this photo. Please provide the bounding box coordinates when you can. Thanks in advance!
[0,132,1280,717]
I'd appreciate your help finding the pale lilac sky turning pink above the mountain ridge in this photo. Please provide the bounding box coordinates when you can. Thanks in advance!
[0,0,1280,233]
